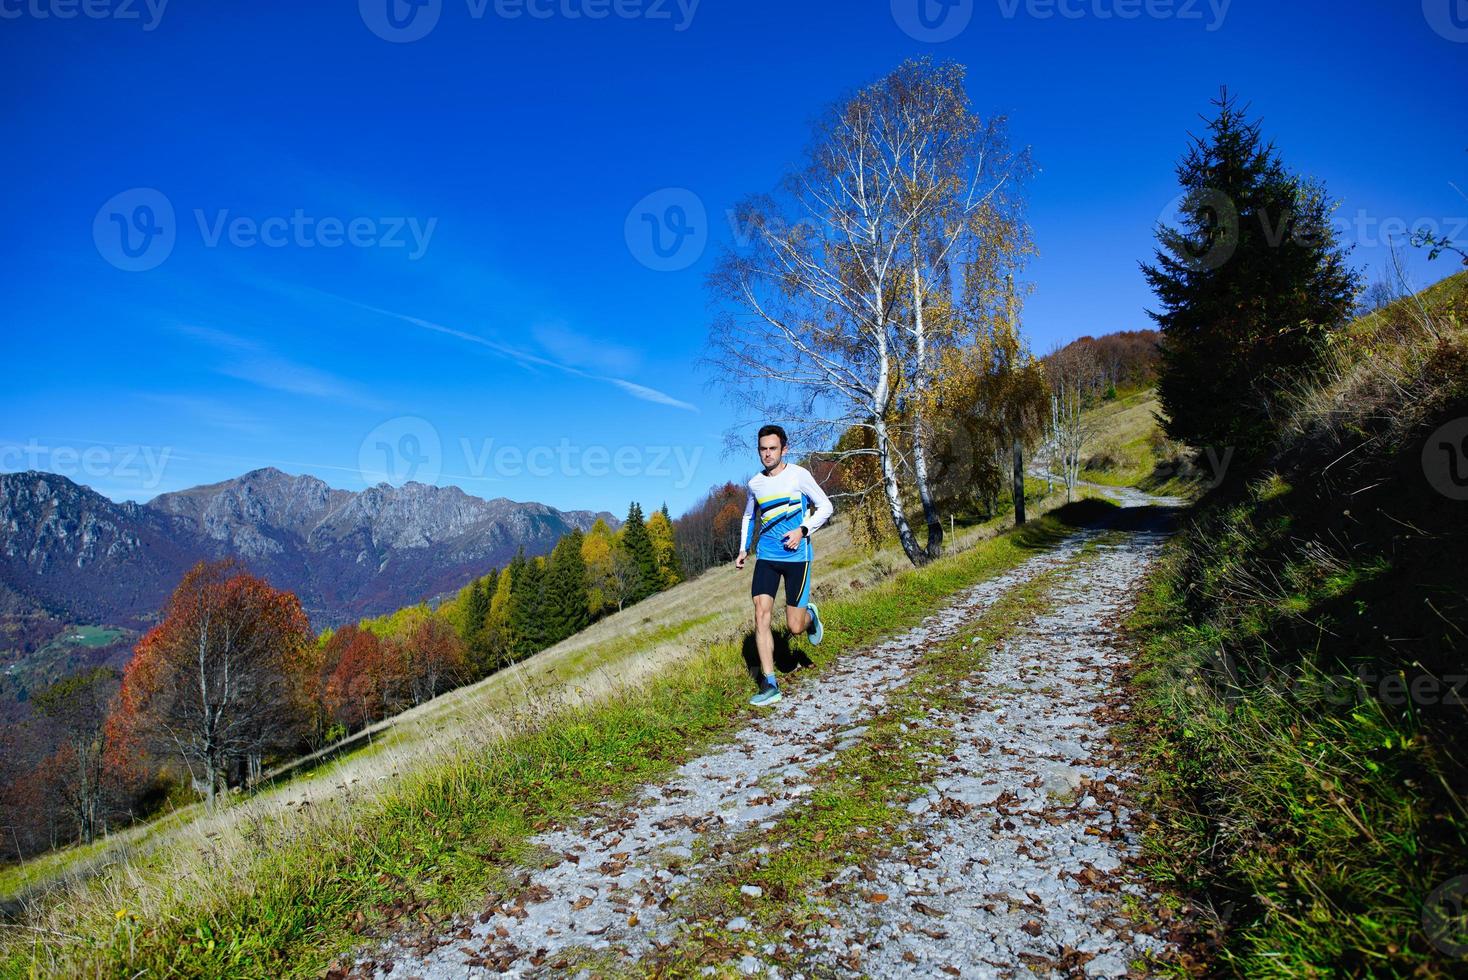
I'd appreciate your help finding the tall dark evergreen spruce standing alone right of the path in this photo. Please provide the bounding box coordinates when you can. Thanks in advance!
[1142,91,1361,461]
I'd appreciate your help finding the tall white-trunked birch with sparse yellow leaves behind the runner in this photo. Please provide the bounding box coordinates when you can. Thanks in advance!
[711,62,1028,565]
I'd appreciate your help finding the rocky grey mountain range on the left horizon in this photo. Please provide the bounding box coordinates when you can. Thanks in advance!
[0,468,618,707]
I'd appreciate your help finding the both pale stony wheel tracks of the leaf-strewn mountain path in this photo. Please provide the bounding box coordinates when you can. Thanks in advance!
[357,510,1164,980]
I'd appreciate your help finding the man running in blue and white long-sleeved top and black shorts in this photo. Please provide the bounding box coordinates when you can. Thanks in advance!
[734,425,834,704]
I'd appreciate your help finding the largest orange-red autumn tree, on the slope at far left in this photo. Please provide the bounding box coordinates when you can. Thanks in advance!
[116,559,311,804]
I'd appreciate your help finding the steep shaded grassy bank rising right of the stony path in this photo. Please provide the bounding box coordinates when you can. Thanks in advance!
[1133,273,1468,977]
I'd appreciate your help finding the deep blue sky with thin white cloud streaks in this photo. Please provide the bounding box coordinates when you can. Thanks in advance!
[0,0,1468,515]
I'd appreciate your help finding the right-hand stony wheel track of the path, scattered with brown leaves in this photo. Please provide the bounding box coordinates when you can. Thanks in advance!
[791,533,1169,977]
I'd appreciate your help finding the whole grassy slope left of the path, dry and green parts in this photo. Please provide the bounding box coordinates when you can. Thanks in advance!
[0,454,1121,976]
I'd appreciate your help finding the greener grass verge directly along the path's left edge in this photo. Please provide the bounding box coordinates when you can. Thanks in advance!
[0,501,1103,977]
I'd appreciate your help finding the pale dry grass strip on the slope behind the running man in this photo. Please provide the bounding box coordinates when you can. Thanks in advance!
[0,484,1092,933]
